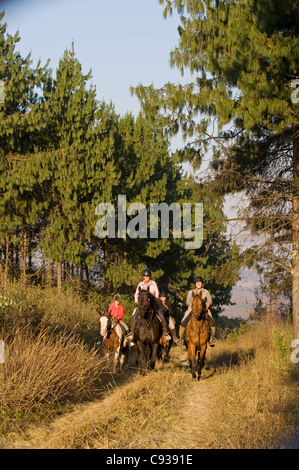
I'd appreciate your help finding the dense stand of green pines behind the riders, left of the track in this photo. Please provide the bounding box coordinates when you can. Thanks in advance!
[0,9,242,313]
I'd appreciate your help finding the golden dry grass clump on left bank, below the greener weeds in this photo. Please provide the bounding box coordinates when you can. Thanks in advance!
[0,329,103,411]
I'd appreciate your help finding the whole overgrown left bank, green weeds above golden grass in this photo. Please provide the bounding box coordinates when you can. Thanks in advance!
[0,284,107,432]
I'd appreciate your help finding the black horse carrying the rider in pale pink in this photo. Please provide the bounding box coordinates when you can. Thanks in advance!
[133,287,163,370]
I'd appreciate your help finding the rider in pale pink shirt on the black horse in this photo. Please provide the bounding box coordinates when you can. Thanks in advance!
[128,268,171,341]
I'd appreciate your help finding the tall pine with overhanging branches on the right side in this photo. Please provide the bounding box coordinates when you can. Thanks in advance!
[137,0,299,337]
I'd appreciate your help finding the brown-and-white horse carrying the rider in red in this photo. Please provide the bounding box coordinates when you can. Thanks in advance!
[100,312,130,372]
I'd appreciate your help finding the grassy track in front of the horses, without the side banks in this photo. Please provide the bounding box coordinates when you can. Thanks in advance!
[2,347,218,449]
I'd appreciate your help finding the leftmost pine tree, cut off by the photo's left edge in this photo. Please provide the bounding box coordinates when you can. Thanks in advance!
[0,13,49,284]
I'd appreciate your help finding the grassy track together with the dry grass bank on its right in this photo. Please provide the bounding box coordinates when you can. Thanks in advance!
[0,325,299,449]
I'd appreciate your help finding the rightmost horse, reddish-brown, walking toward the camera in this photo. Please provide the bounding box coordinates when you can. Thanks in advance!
[185,292,210,380]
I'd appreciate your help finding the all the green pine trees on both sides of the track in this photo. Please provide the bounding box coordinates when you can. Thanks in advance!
[0,0,299,338]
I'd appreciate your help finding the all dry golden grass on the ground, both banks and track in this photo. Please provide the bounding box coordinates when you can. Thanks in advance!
[0,284,299,449]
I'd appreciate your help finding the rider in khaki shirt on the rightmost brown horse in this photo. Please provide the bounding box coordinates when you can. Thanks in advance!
[178,276,217,346]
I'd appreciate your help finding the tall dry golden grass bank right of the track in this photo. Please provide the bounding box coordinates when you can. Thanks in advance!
[209,318,299,449]
